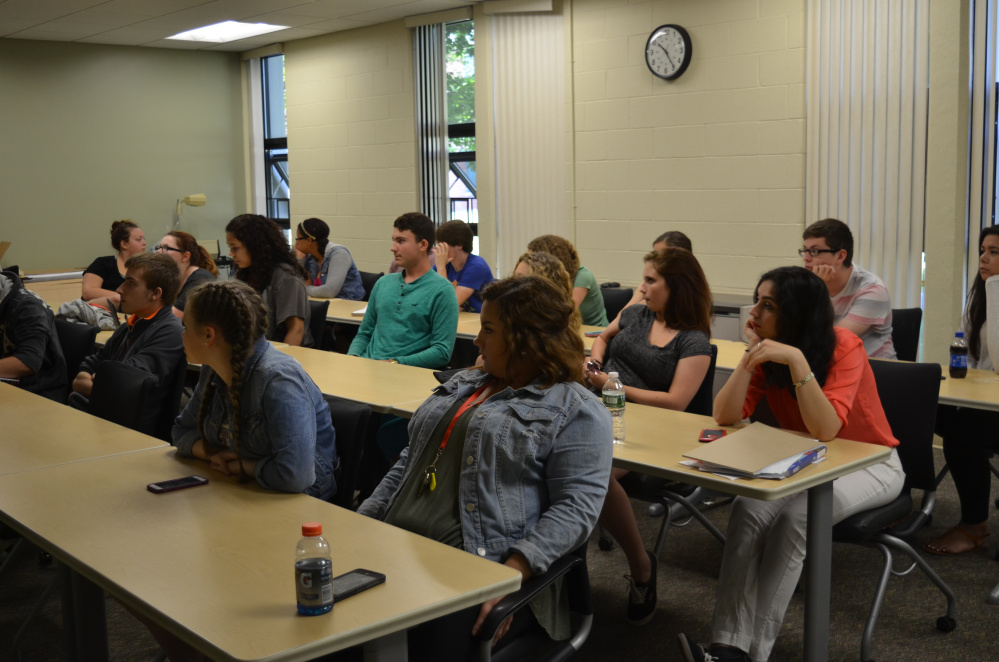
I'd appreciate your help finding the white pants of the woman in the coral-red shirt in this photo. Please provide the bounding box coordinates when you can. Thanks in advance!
[711,450,905,662]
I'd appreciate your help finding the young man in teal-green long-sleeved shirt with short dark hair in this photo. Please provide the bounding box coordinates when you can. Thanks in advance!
[347,212,458,368]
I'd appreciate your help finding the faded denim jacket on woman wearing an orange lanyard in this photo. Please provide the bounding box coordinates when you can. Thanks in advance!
[358,370,613,573]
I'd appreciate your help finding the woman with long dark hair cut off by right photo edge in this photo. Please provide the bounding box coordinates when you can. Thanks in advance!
[923,225,999,554]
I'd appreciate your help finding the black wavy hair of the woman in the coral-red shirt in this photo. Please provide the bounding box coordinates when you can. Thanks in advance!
[753,267,836,395]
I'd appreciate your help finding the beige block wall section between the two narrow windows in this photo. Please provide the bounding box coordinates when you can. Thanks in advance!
[285,22,416,272]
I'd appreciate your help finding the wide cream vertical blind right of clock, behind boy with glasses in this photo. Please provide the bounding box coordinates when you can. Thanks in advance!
[805,0,929,308]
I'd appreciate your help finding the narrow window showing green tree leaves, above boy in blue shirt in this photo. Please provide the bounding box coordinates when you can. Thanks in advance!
[444,21,479,253]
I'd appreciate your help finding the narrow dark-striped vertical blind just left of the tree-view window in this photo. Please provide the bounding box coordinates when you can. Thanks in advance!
[413,23,449,225]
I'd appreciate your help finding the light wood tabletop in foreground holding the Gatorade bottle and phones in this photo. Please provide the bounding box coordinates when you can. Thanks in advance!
[0,449,520,662]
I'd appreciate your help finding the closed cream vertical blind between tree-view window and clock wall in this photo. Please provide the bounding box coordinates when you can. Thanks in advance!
[491,14,567,276]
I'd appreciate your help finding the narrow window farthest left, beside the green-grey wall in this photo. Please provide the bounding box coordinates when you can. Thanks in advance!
[260,55,291,231]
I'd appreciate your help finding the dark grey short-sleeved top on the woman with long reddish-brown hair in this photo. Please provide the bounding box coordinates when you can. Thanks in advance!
[604,306,711,391]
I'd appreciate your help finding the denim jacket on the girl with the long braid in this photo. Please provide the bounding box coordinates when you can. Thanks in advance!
[173,338,337,499]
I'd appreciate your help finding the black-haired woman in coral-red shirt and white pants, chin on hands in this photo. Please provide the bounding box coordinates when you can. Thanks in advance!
[680,267,905,662]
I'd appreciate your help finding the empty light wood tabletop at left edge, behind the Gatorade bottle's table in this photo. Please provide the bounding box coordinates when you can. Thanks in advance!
[0,384,166,475]
